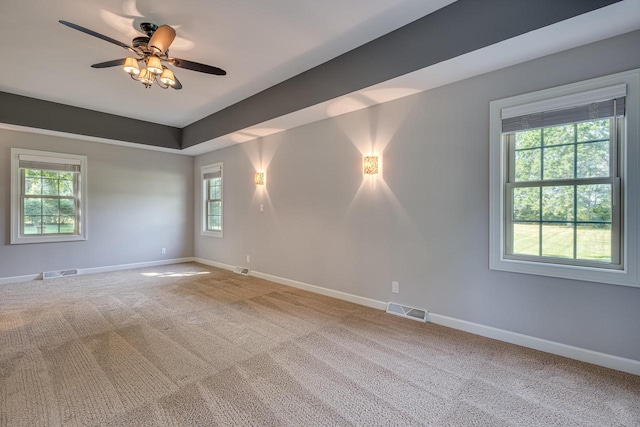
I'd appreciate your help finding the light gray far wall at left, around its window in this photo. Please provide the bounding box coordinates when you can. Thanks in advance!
[0,129,193,278]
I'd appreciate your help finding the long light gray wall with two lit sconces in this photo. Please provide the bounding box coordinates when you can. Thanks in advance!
[194,32,640,360]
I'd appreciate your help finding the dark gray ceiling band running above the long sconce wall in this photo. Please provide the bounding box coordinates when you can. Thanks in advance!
[182,0,619,148]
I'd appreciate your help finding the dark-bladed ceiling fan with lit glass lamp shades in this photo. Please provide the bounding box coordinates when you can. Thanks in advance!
[59,20,227,89]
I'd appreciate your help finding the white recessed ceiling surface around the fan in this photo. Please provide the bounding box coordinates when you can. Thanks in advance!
[0,0,453,127]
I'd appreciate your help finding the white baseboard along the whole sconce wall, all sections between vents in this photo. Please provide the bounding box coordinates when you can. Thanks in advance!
[194,258,640,375]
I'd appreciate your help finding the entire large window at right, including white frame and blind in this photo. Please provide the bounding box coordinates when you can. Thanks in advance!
[490,71,640,286]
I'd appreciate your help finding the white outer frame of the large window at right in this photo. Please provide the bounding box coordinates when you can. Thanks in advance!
[489,70,640,287]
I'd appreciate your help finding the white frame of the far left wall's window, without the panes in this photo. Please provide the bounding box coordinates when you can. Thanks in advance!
[11,148,88,245]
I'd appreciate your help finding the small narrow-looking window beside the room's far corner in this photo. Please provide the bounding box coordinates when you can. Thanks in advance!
[201,163,223,237]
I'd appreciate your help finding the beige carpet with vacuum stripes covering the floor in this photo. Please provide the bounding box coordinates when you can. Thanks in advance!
[0,264,640,426]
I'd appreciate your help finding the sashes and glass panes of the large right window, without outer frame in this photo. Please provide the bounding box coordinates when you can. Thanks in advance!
[503,108,624,268]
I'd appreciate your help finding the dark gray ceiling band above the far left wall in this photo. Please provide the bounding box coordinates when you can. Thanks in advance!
[0,92,181,150]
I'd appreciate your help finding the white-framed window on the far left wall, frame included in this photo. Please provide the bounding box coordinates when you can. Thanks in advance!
[11,148,87,244]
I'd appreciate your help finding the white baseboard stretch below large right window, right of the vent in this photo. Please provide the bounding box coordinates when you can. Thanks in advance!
[428,313,640,375]
